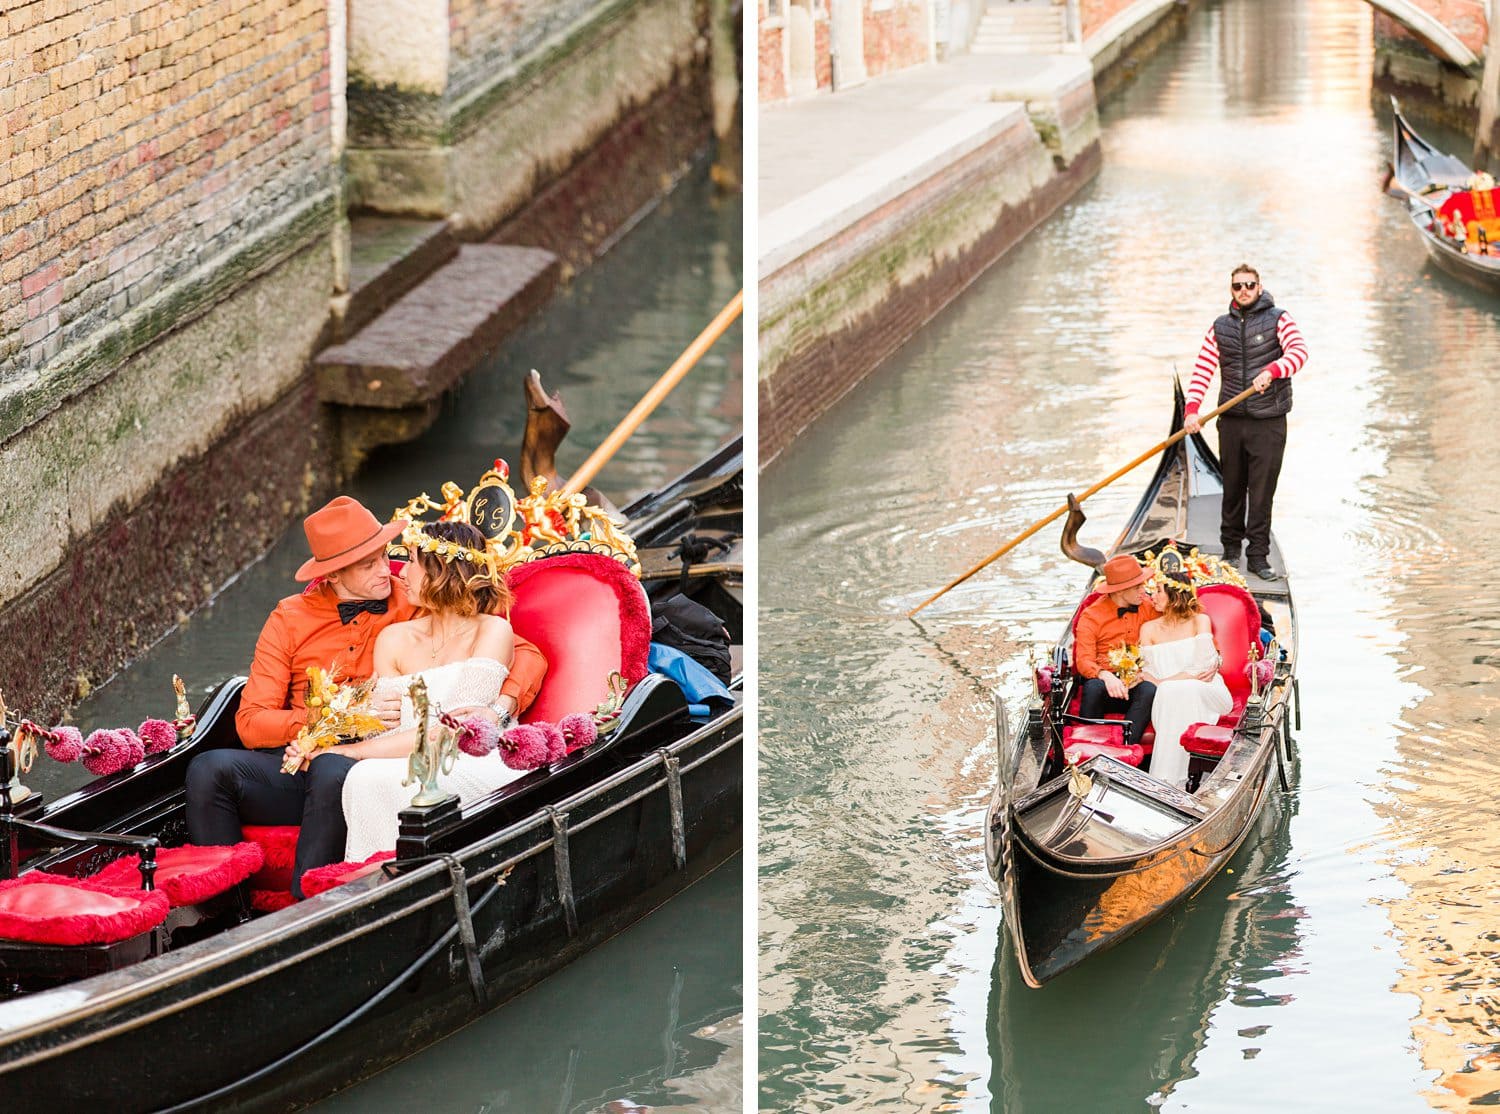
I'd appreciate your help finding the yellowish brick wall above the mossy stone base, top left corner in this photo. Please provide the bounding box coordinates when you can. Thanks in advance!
[0,0,333,391]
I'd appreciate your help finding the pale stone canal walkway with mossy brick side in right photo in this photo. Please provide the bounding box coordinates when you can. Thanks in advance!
[759,0,1185,466]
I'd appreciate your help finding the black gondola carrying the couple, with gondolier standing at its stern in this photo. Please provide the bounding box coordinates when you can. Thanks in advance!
[986,385,1298,987]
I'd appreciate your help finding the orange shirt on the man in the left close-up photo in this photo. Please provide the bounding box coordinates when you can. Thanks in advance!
[234,580,548,748]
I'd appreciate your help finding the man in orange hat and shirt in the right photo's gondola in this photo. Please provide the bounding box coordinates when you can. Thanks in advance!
[1073,553,1157,742]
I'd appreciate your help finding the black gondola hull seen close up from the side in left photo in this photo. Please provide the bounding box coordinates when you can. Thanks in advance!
[0,439,743,1111]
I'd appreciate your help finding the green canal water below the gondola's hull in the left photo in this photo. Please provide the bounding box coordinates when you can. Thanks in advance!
[315,856,744,1114]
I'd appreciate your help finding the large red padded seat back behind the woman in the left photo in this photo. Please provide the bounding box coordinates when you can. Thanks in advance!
[510,553,651,723]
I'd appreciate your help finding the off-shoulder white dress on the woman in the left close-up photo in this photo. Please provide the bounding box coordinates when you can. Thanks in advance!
[344,658,527,862]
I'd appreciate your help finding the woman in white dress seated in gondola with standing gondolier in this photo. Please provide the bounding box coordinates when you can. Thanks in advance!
[1140,570,1235,789]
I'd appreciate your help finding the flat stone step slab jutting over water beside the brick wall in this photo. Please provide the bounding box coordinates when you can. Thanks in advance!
[314,244,558,409]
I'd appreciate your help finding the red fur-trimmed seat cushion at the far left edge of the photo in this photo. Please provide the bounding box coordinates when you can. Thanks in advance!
[0,871,170,945]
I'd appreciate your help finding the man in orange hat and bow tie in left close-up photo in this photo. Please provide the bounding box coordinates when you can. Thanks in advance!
[188,495,548,897]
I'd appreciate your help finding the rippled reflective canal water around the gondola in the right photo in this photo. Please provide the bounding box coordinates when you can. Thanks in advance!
[759,0,1500,1114]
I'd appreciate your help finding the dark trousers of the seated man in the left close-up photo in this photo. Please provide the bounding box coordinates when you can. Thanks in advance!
[188,747,354,898]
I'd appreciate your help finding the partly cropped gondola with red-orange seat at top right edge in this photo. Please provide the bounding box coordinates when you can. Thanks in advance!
[1388,97,1500,292]
